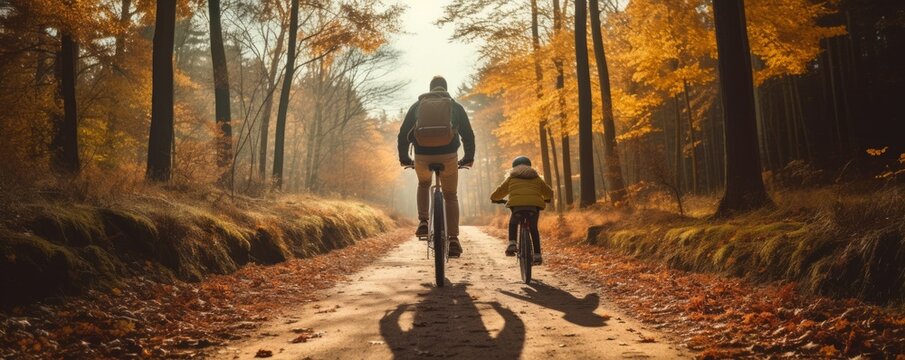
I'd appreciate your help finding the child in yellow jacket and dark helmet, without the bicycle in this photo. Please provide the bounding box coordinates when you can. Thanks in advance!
[490,156,553,264]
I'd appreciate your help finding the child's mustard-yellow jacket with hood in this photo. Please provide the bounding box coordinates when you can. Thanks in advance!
[490,165,553,209]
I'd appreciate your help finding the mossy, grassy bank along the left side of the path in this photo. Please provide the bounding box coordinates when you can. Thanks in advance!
[0,184,395,307]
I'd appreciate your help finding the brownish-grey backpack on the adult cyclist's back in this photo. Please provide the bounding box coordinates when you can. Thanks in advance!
[412,92,457,147]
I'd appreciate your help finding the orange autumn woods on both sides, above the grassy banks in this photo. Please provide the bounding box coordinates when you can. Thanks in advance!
[0,0,905,213]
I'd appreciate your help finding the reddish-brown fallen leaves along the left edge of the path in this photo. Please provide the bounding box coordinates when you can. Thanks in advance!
[0,230,409,358]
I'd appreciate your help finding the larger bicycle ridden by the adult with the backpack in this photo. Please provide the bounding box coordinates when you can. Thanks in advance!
[405,164,471,287]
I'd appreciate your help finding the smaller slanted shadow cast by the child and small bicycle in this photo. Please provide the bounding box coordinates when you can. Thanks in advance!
[500,281,608,327]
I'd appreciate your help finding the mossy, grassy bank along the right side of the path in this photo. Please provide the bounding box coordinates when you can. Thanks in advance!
[495,185,905,305]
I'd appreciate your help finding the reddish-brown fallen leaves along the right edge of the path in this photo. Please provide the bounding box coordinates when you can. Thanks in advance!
[484,222,905,359]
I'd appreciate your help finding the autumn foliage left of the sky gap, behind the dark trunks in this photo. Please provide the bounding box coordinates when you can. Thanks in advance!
[0,0,403,200]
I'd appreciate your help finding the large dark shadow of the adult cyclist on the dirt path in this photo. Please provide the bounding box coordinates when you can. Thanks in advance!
[380,284,525,359]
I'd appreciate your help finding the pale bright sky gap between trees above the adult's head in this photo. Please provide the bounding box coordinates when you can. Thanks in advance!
[385,0,478,116]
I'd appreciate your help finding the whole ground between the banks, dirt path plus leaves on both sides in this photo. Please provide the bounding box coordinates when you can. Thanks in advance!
[0,227,905,359]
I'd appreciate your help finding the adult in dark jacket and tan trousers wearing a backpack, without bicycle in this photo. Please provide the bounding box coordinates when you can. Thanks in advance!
[397,76,475,257]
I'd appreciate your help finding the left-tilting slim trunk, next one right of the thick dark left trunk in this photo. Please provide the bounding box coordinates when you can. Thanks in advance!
[207,0,233,184]
